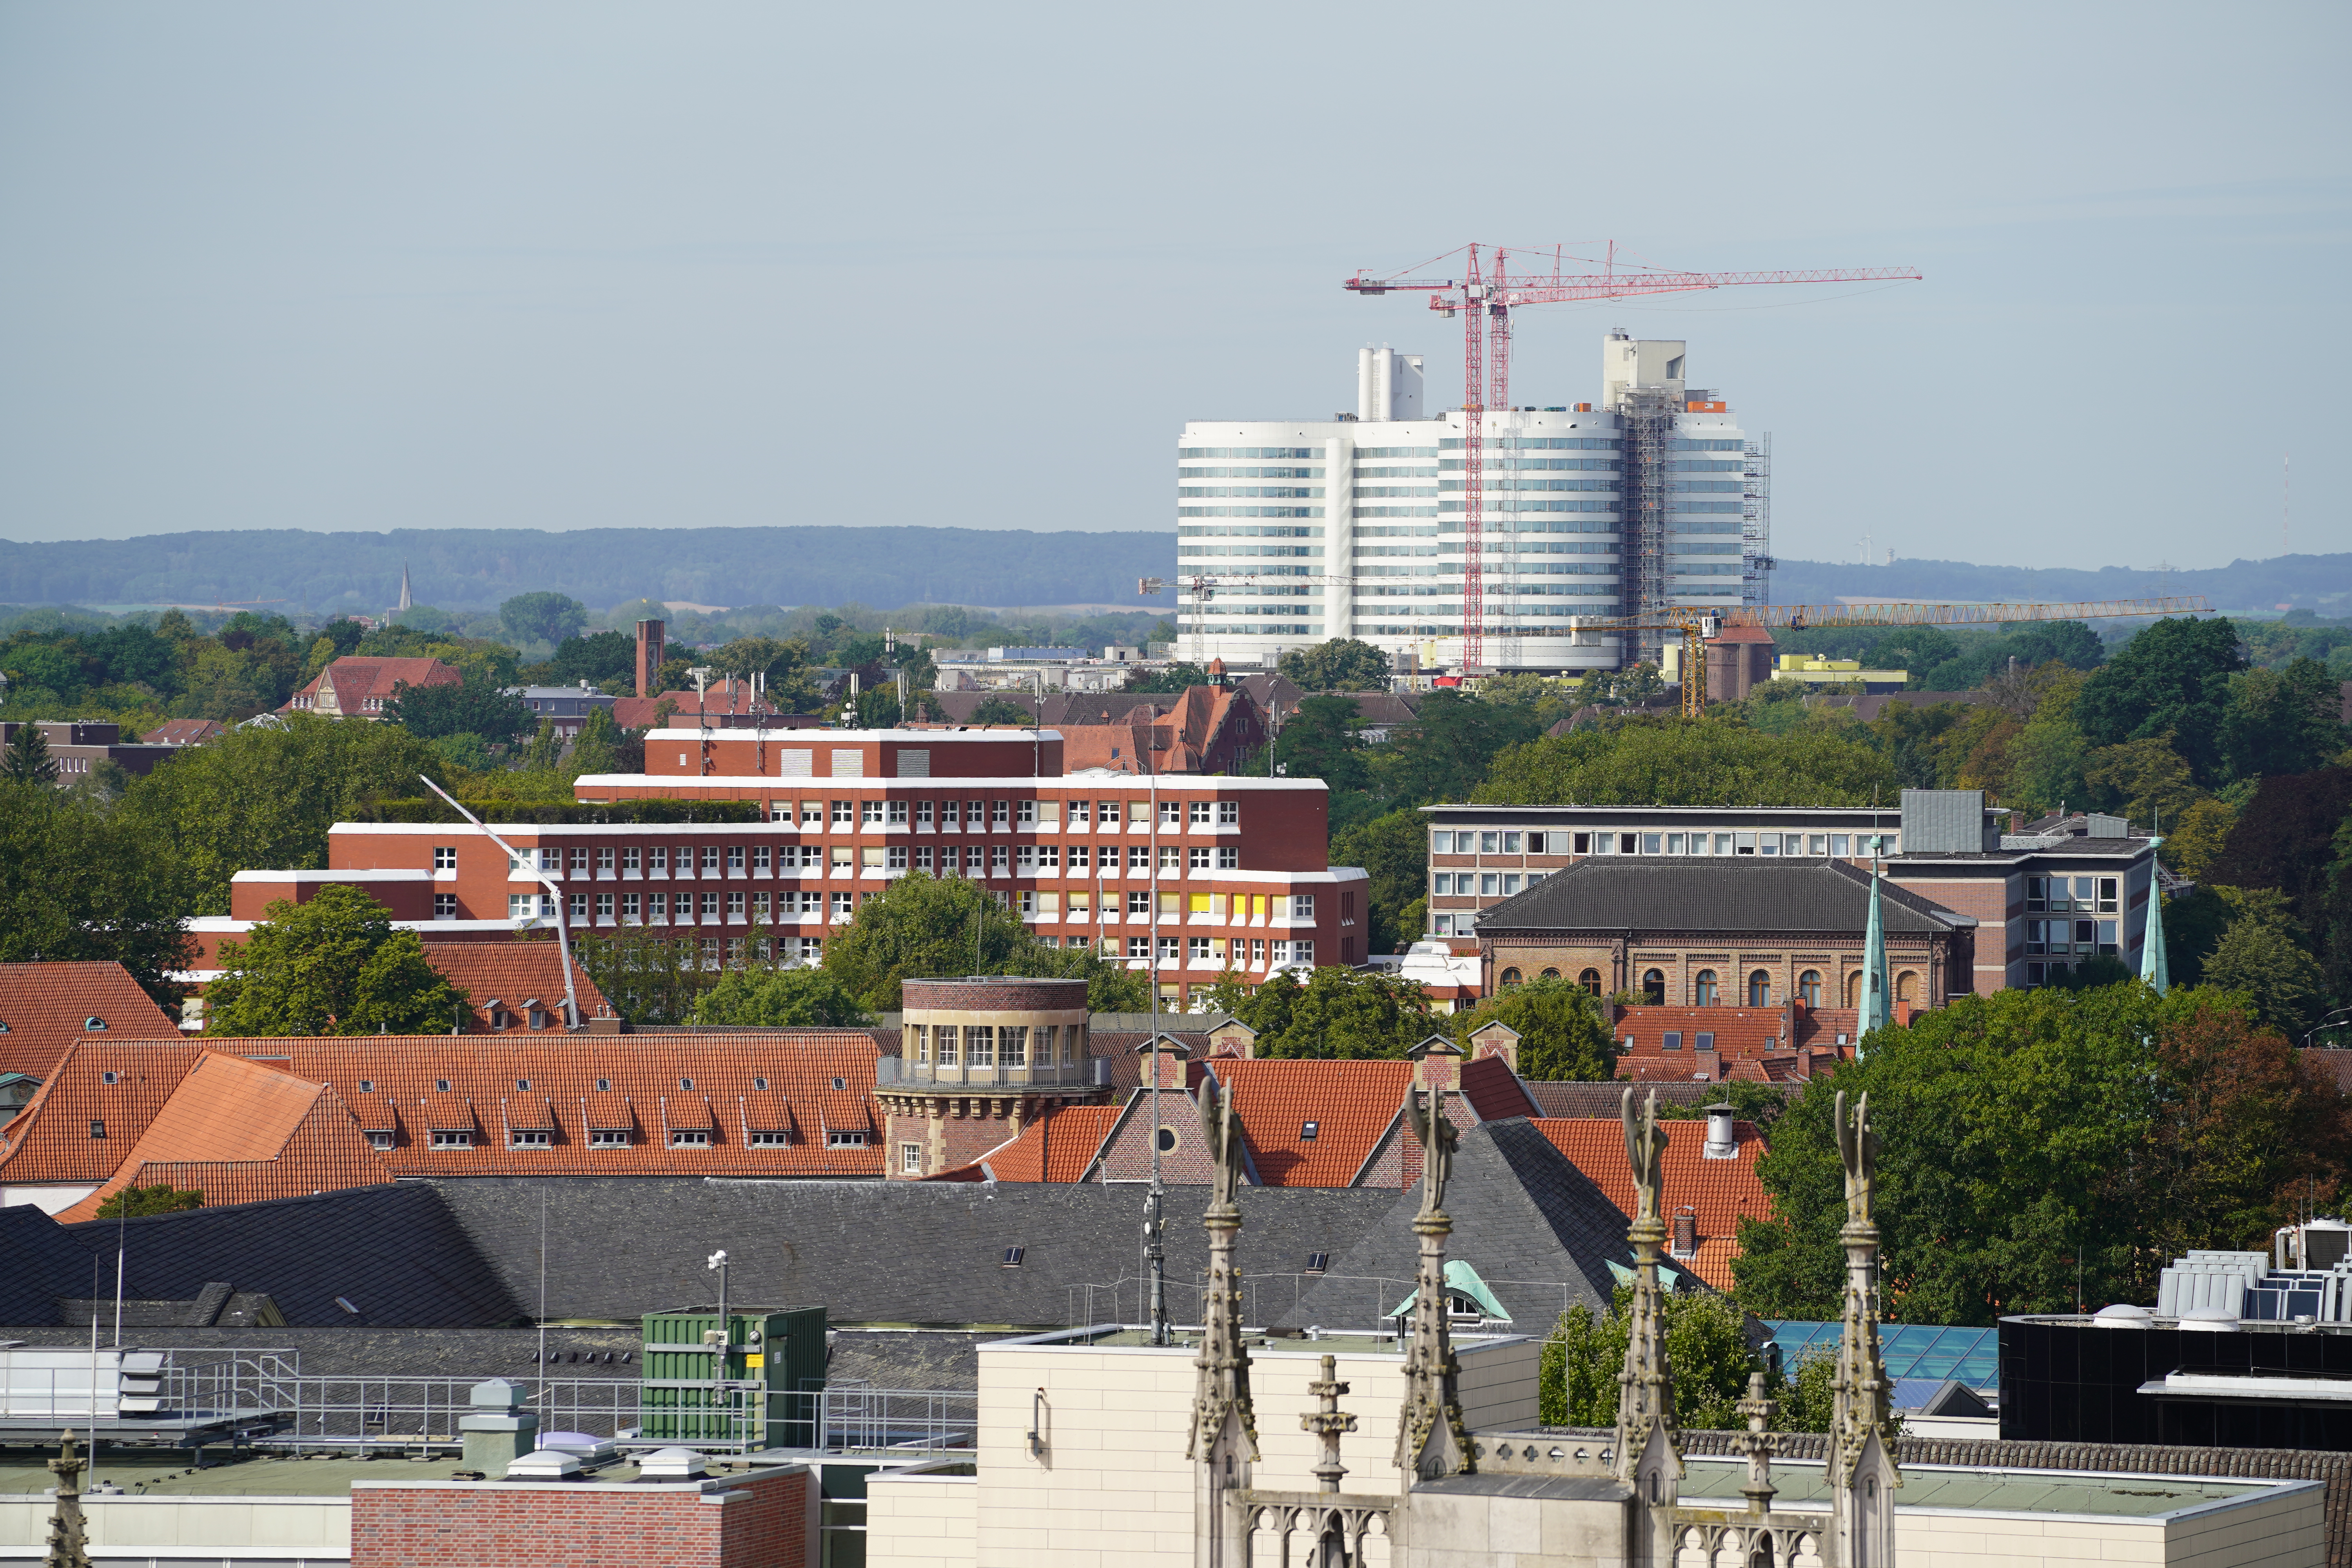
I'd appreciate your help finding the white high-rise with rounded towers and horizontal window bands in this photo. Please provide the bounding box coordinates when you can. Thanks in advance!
[1176,332,1771,672]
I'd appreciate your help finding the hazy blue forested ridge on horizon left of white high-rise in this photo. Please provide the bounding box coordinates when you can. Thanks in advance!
[0,529,1176,611]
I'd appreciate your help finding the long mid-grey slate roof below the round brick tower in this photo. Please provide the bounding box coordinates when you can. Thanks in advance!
[428,1178,1397,1328]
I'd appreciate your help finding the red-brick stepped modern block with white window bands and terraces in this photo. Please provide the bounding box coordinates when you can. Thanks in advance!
[299,729,1367,1004]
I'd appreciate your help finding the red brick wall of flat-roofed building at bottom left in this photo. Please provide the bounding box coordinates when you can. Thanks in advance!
[350,1469,809,1568]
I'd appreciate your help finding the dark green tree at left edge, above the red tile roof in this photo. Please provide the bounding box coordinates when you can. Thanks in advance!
[0,780,195,1006]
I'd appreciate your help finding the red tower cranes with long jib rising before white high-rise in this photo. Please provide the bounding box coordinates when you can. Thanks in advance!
[1343,240,1922,672]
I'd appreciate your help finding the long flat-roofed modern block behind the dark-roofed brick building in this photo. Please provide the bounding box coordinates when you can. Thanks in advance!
[1423,790,2154,1004]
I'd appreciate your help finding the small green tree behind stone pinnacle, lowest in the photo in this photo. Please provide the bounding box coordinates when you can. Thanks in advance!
[1536,1286,1769,1432]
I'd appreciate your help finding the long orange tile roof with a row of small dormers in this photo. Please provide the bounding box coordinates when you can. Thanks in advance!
[0,1030,882,1182]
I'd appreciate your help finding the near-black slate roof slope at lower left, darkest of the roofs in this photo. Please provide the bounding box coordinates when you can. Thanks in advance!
[62,1182,524,1328]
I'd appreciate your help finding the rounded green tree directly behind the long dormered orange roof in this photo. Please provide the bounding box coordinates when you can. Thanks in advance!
[205,882,466,1037]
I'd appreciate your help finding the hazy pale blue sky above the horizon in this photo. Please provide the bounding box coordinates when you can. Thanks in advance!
[0,0,2352,566]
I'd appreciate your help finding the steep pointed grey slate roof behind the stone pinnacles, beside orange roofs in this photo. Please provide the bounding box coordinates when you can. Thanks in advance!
[1270,1117,1632,1333]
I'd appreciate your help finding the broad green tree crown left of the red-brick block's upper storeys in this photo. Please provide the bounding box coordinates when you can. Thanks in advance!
[118,712,449,915]
